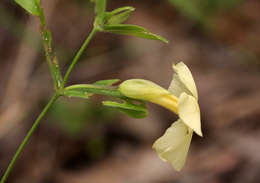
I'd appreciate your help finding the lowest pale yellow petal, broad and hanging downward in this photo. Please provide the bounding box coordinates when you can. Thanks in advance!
[153,119,193,171]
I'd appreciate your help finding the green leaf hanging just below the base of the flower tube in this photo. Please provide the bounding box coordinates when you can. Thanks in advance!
[103,100,148,118]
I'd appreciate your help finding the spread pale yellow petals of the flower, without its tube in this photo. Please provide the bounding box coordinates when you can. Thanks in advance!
[153,62,202,171]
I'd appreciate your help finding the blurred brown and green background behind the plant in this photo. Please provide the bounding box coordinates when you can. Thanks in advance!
[0,0,260,183]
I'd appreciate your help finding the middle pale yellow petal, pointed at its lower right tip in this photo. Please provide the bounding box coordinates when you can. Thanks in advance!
[178,93,202,136]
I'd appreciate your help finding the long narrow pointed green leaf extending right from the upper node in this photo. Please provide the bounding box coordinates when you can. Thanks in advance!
[103,24,168,43]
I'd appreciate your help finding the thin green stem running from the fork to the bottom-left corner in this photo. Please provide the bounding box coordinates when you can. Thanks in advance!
[0,93,60,183]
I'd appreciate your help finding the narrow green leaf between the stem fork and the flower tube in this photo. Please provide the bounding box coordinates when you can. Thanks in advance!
[64,84,125,98]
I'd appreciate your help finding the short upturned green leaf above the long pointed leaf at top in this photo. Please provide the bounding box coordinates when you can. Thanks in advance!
[106,6,135,25]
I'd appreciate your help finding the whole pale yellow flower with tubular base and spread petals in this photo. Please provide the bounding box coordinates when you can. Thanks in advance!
[119,62,202,171]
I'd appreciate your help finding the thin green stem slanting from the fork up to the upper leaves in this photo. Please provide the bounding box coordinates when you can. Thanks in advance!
[62,27,97,88]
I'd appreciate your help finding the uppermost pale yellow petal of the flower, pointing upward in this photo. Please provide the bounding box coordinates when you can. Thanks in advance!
[169,62,198,99]
